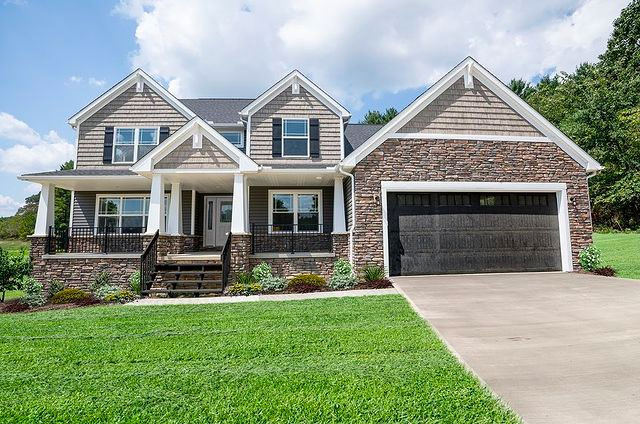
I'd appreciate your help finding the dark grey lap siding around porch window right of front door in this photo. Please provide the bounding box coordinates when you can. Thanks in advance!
[249,186,333,232]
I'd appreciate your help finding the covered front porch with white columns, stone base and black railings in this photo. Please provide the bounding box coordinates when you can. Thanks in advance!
[32,169,348,293]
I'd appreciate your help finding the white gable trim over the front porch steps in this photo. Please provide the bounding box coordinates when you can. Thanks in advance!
[131,116,258,174]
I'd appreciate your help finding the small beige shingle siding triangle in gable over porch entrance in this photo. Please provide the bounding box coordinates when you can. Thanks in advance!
[155,137,238,169]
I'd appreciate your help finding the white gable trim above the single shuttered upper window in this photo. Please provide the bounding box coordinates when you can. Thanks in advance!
[240,69,351,121]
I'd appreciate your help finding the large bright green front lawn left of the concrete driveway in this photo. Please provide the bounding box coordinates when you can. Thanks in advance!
[0,296,518,423]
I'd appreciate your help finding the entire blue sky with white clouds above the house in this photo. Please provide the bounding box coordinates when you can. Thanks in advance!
[0,0,627,216]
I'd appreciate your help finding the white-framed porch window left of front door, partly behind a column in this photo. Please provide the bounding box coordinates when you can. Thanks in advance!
[96,195,169,233]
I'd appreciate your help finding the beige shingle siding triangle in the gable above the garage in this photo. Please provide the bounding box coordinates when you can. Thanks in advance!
[398,78,542,137]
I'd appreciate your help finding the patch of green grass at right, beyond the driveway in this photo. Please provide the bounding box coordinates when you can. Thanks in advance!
[593,233,640,279]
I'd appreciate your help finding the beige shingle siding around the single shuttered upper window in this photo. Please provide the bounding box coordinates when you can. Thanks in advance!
[250,87,341,165]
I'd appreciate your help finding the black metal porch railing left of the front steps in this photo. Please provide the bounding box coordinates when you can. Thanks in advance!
[47,227,146,254]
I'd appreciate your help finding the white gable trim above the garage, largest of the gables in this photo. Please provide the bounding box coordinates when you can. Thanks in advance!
[342,57,602,172]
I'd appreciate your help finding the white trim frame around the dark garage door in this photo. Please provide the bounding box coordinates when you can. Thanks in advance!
[381,181,573,275]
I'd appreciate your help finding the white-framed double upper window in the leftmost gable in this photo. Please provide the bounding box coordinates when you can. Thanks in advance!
[112,128,160,163]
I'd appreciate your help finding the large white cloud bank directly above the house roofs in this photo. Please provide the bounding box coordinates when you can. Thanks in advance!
[115,0,628,108]
